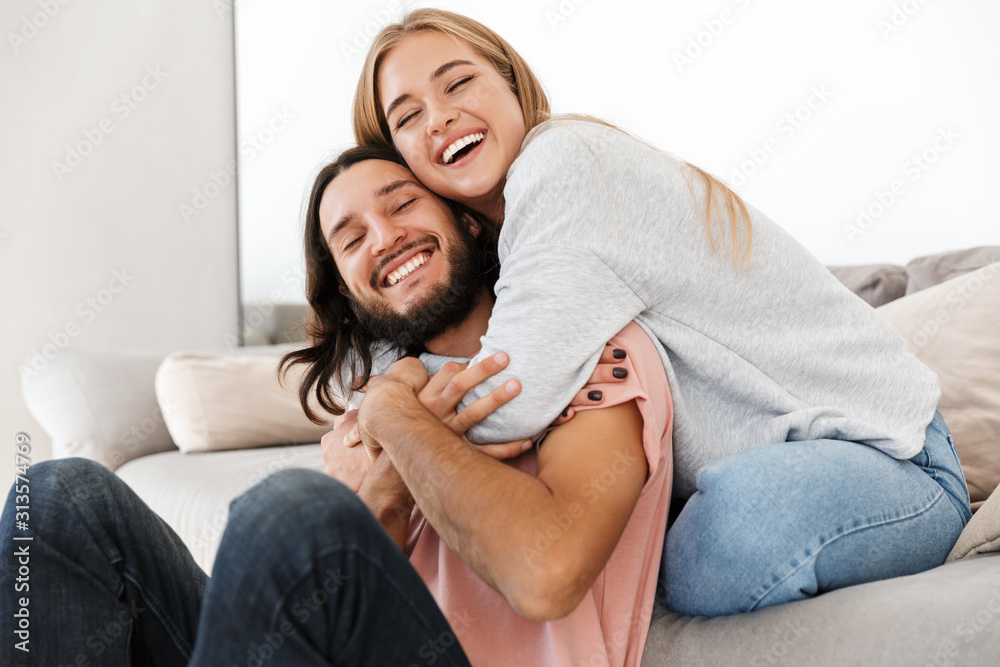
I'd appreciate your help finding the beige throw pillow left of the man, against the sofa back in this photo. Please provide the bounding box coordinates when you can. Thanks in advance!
[156,352,333,453]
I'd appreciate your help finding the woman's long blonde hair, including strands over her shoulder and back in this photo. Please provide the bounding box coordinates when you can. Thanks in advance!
[354,9,753,268]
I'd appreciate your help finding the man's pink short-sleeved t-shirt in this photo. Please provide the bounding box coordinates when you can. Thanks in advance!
[406,322,673,667]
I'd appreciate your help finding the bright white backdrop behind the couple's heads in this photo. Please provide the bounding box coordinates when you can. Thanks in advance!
[236,0,1000,302]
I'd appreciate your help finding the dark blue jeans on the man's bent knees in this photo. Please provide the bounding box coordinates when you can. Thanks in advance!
[0,459,469,667]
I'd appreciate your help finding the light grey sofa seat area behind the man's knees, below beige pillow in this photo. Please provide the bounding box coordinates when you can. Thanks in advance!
[118,444,323,572]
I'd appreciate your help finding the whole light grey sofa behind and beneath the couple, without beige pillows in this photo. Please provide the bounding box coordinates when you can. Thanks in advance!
[24,248,1000,667]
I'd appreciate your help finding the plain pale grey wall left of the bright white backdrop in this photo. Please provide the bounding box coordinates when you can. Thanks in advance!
[0,0,238,478]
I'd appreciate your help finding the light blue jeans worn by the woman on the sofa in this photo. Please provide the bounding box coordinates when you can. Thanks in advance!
[660,413,972,616]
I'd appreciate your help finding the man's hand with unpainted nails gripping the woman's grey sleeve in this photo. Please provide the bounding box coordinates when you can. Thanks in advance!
[344,352,531,460]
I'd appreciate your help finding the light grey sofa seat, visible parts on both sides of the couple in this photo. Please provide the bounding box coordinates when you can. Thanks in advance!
[118,444,1000,667]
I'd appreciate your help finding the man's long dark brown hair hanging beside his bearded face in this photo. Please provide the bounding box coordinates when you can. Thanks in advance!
[278,146,500,424]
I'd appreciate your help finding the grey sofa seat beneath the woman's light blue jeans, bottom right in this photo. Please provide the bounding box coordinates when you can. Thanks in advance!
[642,554,1000,667]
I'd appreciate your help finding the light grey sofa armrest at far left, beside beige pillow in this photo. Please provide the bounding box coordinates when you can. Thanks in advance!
[21,348,176,470]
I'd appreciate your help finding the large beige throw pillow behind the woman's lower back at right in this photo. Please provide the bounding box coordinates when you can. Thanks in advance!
[878,262,1000,509]
